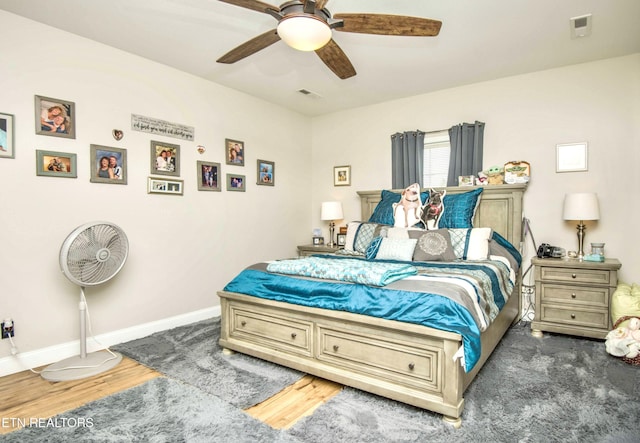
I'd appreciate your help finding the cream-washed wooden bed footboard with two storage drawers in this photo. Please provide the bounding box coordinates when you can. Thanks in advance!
[218,291,517,426]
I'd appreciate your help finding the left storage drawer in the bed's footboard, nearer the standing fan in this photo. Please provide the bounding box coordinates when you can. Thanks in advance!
[229,304,312,356]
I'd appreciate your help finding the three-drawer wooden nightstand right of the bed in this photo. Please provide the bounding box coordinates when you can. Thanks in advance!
[531,258,622,339]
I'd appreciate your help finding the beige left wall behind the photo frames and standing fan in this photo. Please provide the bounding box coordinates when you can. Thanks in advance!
[0,11,311,370]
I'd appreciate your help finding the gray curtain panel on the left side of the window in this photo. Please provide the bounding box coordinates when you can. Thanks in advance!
[391,131,424,189]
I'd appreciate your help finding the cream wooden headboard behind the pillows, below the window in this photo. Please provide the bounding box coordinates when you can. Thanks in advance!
[358,183,527,248]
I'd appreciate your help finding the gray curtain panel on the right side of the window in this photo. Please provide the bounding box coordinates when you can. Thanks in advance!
[447,121,484,186]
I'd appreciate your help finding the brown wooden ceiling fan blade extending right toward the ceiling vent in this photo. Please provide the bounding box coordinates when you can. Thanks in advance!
[333,14,442,37]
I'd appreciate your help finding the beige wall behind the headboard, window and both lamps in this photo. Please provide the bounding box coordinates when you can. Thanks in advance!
[312,54,640,282]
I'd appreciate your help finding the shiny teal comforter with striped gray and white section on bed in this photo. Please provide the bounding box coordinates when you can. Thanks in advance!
[224,256,514,371]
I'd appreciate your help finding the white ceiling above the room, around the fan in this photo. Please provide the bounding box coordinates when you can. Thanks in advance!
[0,0,640,116]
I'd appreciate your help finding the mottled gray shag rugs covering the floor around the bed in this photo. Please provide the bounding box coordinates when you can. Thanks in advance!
[0,319,640,443]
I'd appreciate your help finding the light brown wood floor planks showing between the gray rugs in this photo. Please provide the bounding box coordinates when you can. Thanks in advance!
[0,357,342,434]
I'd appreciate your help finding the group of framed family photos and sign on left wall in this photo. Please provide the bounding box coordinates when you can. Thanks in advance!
[0,95,275,195]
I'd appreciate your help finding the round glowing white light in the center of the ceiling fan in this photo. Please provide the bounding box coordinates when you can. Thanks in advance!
[278,14,331,51]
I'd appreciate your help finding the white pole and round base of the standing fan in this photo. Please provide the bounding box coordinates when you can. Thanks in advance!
[40,286,122,381]
